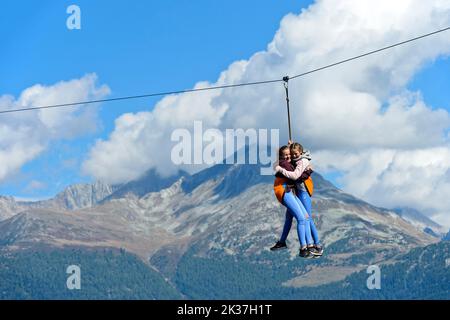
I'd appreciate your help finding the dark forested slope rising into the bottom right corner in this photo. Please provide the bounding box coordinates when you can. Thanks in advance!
[276,241,450,300]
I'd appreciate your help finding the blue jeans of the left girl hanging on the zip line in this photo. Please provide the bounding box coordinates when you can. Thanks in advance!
[280,192,312,247]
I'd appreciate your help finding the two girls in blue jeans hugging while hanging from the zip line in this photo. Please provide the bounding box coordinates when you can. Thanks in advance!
[270,141,323,258]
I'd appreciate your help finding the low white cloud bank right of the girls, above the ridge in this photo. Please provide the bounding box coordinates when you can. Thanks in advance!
[315,145,450,226]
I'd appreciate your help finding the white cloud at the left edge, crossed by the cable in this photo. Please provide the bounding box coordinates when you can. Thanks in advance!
[0,74,109,181]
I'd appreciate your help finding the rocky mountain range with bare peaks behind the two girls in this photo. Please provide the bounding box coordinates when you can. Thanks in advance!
[0,164,448,299]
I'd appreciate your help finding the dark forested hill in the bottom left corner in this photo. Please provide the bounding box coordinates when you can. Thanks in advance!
[0,247,181,300]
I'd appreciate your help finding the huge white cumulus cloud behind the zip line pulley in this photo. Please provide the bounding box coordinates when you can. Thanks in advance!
[84,0,450,225]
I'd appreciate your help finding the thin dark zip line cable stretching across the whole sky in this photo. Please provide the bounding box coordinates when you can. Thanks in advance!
[0,27,450,114]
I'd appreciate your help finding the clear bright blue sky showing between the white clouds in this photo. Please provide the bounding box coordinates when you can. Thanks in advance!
[0,0,450,198]
